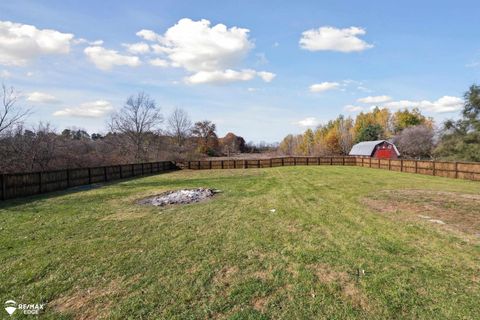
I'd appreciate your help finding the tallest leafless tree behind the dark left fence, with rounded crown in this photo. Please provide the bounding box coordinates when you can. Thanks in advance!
[109,92,163,162]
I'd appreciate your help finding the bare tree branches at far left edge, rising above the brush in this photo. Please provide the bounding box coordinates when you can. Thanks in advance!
[0,84,30,135]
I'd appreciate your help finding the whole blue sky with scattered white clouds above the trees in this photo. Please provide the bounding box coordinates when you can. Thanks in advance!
[0,1,480,142]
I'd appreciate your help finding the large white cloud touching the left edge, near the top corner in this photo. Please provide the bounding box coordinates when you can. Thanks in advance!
[0,21,74,66]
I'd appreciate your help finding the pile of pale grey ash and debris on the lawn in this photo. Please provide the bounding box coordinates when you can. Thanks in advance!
[138,188,220,207]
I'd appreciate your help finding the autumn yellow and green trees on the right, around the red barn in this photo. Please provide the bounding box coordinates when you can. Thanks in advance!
[279,85,480,161]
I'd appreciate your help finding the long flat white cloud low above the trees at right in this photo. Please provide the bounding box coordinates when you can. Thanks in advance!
[383,96,464,113]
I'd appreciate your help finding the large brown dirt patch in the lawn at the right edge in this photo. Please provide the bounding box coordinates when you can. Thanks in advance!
[362,190,480,235]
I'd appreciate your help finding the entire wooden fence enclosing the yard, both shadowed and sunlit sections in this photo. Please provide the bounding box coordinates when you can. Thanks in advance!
[0,156,480,200]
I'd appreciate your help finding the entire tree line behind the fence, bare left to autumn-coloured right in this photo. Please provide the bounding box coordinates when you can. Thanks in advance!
[0,85,480,172]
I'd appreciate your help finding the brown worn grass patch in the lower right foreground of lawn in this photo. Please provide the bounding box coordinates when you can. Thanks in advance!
[310,264,371,311]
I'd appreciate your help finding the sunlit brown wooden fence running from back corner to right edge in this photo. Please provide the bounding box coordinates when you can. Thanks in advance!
[178,156,480,180]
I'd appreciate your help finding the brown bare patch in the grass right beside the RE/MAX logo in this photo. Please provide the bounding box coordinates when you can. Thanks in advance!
[48,281,121,320]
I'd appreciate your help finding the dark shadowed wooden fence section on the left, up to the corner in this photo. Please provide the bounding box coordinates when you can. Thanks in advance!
[0,161,177,200]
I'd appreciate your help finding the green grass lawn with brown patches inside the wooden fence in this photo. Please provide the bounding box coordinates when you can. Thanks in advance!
[0,166,480,319]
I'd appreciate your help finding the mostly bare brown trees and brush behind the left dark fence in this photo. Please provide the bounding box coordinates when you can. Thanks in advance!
[0,85,258,173]
